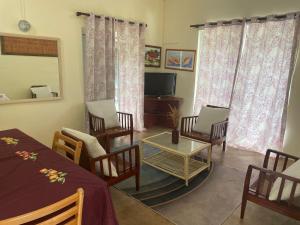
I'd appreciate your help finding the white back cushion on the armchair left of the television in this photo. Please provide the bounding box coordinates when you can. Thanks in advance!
[86,99,120,128]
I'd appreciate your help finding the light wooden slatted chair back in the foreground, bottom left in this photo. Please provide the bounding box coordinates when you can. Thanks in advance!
[0,188,84,225]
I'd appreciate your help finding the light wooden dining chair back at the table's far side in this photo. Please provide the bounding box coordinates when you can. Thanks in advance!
[52,131,82,165]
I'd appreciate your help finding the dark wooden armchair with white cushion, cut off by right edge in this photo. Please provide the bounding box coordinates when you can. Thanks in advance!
[240,149,300,221]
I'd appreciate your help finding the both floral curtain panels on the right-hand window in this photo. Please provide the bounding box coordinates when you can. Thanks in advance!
[194,14,299,153]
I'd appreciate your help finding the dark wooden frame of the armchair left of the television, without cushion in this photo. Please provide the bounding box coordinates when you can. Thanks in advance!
[89,112,133,153]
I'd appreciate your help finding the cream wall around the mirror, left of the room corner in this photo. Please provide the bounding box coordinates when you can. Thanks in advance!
[0,0,163,145]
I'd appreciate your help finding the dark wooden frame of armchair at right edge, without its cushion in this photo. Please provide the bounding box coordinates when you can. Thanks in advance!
[240,149,300,220]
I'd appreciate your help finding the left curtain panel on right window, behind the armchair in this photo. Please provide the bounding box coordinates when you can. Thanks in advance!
[194,24,242,114]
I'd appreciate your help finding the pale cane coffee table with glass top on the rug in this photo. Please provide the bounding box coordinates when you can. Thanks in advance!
[141,132,211,186]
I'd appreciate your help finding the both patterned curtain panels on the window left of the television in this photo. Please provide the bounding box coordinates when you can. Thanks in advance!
[84,15,145,130]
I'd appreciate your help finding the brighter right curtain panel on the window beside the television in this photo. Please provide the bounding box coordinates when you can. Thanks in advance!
[115,21,145,131]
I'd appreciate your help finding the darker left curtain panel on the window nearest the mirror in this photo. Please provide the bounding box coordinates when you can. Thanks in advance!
[84,15,115,101]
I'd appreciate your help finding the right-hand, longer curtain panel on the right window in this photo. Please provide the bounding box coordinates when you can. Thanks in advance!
[228,17,296,153]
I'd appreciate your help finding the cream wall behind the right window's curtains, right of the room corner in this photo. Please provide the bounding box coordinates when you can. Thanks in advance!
[164,0,300,156]
